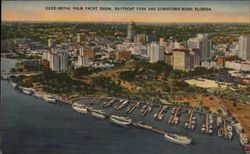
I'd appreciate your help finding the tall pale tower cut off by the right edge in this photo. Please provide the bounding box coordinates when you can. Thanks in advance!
[238,35,250,60]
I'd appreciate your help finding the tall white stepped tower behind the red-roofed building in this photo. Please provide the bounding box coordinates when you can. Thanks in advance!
[187,34,212,61]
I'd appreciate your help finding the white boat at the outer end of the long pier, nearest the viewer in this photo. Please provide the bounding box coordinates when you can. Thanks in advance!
[164,133,192,145]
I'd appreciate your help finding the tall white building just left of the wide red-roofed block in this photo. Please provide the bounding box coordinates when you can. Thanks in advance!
[148,42,165,63]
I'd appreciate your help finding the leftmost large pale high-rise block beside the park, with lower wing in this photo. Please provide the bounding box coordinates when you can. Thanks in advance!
[43,51,68,72]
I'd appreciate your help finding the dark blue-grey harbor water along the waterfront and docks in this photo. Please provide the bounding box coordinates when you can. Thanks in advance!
[0,59,244,154]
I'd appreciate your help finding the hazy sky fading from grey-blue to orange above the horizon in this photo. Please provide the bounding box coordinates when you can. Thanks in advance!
[1,1,250,23]
